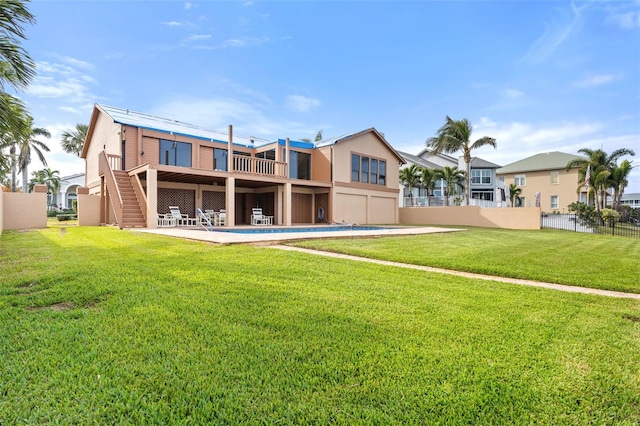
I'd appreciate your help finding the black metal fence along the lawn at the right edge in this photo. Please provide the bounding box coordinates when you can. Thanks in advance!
[540,212,640,238]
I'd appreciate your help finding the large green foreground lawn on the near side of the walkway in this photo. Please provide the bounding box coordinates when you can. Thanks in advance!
[0,227,640,425]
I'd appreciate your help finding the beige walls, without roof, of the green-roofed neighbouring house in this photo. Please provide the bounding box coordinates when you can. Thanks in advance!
[498,168,579,212]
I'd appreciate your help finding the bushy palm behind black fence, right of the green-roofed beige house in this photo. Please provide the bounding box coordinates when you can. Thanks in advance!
[567,148,635,212]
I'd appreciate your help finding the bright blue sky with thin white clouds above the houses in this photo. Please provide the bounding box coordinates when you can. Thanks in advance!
[13,0,640,192]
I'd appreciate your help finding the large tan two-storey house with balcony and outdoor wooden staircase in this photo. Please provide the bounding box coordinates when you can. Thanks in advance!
[81,105,403,227]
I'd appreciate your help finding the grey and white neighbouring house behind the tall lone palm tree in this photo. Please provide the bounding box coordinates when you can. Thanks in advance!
[398,149,501,205]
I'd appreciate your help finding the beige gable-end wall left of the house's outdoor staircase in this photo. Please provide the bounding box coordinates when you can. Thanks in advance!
[85,113,122,186]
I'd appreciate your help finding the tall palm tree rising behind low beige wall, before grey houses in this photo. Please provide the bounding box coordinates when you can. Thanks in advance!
[426,115,497,206]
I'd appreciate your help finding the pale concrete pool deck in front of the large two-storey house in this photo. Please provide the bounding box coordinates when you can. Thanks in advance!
[130,225,464,244]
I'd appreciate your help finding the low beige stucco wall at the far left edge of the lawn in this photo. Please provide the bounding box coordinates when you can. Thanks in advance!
[2,191,47,230]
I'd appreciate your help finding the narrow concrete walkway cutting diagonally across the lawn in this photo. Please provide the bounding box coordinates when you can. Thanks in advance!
[268,245,640,300]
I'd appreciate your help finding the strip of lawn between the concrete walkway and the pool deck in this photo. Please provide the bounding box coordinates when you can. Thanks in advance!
[295,228,640,293]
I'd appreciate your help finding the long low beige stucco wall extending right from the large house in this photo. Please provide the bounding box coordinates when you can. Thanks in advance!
[399,206,540,229]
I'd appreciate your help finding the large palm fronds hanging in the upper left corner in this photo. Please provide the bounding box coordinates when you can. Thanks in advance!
[0,0,36,129]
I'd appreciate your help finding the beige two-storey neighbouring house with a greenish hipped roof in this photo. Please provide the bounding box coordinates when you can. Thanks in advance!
[496,151,586,212]
